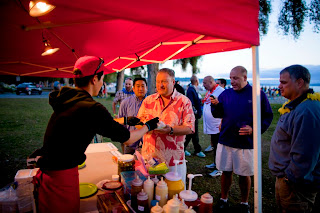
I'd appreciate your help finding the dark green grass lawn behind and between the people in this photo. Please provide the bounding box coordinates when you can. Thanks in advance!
[0,98,319,212]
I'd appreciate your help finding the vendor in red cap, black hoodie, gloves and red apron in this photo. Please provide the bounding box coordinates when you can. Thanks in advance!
[34,56,159,213]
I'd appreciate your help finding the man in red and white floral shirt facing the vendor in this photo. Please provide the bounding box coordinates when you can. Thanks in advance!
[137,68,195,183]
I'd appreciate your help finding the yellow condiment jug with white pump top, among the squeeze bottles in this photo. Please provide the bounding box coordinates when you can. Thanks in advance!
[165,160,184,199]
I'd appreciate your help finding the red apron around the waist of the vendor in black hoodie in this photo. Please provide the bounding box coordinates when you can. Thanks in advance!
[33,167,80,213]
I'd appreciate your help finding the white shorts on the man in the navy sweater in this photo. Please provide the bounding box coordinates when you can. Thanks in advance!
[216,143,253,176]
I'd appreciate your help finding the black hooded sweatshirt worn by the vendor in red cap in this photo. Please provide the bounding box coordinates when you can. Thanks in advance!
[38,87,130,170]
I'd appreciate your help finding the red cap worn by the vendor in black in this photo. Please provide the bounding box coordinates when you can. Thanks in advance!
[73,55,107,78]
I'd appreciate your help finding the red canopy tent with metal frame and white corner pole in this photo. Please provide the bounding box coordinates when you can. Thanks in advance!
[0,0,262,212]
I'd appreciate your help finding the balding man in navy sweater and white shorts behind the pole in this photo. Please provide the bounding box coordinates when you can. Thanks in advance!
[211,66,273,212]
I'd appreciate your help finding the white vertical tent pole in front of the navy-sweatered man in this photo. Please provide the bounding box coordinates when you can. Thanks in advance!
[252,46,262,213]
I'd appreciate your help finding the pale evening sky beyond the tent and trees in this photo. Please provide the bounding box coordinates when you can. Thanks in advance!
[160,0,320,78]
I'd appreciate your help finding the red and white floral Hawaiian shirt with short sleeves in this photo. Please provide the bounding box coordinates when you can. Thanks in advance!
[137,90,195,166]
